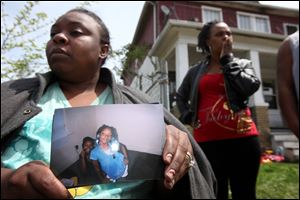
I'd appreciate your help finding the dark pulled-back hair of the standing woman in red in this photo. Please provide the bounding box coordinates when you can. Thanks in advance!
[198,20,221,53]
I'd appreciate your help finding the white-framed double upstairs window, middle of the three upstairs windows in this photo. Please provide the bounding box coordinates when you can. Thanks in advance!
[237,12,271,33]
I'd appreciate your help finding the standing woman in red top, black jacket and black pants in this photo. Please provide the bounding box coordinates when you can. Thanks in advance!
[176,21,260,199]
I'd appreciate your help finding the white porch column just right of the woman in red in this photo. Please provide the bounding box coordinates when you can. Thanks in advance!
[249,50,269,107]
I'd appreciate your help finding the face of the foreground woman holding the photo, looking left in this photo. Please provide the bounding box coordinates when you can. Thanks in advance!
[46,12,108,82]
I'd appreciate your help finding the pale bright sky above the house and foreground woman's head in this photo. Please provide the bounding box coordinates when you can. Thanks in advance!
[1,1,299,81]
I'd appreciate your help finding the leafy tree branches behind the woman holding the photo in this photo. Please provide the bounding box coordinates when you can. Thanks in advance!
[1,1,142,82]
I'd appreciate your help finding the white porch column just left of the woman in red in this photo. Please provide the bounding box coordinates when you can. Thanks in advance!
[175,42,189,90]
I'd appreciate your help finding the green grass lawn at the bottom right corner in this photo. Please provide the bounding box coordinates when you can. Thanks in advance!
[256,163,299,199]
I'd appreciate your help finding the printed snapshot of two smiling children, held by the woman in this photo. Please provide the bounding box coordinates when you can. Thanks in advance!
[50,104,165,188]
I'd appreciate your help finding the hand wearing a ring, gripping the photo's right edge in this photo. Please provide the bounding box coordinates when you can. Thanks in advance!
[163,125,194,189]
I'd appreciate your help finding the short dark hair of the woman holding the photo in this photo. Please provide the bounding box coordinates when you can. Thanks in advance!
[66,8,111,65]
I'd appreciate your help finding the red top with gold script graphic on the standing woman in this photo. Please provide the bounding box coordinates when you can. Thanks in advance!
[194,73,258,142]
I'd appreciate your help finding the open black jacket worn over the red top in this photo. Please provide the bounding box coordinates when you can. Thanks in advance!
[176,55,260,127]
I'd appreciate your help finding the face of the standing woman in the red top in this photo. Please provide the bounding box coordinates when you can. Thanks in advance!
[207,22,233,55]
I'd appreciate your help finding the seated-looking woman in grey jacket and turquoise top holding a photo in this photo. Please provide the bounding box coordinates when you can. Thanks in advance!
[1,8,216,199]
